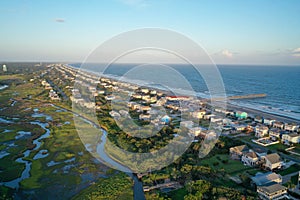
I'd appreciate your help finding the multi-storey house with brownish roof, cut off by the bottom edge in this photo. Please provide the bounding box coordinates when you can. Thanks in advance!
[257,183,289,200]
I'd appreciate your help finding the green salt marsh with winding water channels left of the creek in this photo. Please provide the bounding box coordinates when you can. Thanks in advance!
[0,69,113,198]
